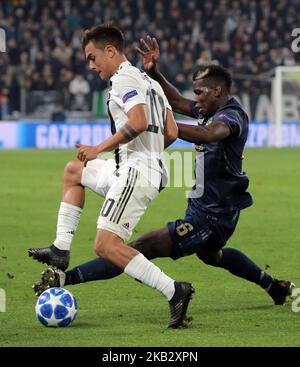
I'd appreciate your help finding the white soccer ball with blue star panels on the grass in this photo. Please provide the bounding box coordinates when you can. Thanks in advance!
[35,287,77,326]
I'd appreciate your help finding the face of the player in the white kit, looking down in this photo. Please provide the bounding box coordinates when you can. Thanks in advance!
[84,42,113,80]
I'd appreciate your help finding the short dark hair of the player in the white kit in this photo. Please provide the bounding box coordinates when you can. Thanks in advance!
[81,23,125,53]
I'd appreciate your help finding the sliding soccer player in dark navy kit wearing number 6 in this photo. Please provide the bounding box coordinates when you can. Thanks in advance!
[33,38,294,305]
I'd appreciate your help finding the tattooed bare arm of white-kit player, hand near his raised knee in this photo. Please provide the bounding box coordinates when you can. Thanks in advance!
[76,104,148,165]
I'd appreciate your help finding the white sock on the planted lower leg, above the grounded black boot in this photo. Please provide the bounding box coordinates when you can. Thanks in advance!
[124,253,175,301]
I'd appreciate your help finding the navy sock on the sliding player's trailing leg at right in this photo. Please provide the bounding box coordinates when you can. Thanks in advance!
[218,248,274,288]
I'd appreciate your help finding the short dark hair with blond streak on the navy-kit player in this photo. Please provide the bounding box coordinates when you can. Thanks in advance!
[193,64,232,93]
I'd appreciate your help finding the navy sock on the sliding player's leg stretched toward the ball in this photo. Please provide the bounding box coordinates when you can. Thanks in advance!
[65,257,123,285]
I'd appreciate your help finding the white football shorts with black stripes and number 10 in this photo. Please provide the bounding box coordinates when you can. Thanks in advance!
[81,159,159,241]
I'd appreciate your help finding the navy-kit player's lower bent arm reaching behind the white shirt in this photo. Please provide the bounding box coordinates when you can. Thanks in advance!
[177,121,231,144]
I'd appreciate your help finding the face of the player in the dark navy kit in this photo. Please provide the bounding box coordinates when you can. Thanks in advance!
[193,79,220,116]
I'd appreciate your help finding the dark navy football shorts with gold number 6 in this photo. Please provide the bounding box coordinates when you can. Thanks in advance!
[167,208,240,260]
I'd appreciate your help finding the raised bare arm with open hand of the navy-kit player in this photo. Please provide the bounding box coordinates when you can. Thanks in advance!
[136,36,195,117]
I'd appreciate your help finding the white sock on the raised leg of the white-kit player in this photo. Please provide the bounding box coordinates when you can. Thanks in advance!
[53,202,82,250]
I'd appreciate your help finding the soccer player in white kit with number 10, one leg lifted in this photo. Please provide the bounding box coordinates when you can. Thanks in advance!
[29,24,194,328]
